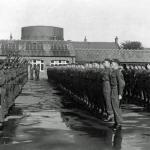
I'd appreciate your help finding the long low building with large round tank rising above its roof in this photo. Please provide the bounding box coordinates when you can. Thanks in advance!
[0,26,150,75]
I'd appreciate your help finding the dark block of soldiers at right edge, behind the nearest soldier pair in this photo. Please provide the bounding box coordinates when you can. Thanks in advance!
[121,64,150,109]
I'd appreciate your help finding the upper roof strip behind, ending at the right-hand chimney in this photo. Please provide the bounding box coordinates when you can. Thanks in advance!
[71,42,119,49]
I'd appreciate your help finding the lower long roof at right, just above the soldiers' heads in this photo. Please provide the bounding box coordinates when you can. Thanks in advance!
[75,49,150,62]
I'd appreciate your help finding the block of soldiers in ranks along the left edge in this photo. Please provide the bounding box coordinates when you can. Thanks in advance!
[0,56,28,125]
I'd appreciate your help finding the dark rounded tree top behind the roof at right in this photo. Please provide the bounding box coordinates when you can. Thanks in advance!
[121,41,144,49]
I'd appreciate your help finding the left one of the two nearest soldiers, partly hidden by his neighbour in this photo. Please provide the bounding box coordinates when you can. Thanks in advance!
[102,59,113,121]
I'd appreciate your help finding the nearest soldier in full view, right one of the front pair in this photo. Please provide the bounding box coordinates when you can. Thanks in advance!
[110,59,125,129]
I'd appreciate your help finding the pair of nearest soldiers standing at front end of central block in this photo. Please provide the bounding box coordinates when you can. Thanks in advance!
[102,59,125,129]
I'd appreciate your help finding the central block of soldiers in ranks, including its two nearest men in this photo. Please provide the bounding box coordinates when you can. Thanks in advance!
[47,59,125,128]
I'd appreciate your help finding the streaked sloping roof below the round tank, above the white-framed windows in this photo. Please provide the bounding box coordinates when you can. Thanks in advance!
[0,40,75,57]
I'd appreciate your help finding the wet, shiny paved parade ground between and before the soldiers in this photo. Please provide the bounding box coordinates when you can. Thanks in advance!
[0,79,150,150]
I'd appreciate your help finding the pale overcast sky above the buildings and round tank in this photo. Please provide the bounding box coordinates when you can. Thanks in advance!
[0,0,150,47]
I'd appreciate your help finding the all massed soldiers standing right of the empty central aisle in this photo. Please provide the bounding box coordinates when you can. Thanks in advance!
[47,59,150,128]
